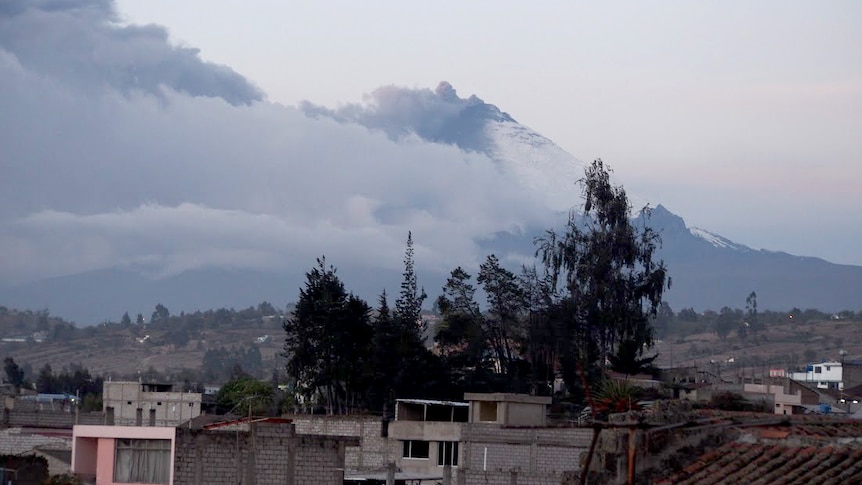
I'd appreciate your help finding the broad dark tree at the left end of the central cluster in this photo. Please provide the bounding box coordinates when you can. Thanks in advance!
[283,258,373,414]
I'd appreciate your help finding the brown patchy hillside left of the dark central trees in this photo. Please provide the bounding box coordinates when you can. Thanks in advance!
[0,307,283,380]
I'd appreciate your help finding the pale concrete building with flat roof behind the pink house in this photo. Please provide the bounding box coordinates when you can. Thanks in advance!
[102,381,201,426]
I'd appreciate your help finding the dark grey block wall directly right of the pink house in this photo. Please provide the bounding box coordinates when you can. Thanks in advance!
[174,423,358,485]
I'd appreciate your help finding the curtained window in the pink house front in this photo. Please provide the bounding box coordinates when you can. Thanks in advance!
[114,438,171,483]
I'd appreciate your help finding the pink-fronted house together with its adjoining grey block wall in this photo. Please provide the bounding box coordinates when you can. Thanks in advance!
[72,416,359,485]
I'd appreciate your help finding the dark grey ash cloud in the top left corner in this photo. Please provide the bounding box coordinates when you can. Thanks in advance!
[0,0,263,105]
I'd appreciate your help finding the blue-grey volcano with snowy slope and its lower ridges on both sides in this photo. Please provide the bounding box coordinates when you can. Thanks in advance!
[0,81,862,324]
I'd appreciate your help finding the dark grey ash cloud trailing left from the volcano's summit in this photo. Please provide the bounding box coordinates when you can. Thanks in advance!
[301,81,514,153]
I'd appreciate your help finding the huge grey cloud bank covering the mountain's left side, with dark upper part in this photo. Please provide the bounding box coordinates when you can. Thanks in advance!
[0,1,548,285]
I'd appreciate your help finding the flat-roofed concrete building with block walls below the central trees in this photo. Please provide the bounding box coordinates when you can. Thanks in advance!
[298,393,592,485]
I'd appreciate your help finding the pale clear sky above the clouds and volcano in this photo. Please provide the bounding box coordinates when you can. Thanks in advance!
[118,0,862,265]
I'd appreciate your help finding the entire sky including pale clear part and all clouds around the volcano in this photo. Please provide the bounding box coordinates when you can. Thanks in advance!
[0,0,862,296]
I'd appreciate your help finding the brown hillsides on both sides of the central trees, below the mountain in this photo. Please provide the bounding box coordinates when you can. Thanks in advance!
[0,303,862,383]
